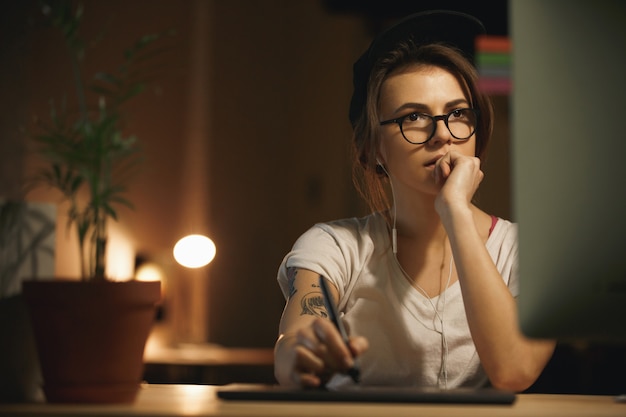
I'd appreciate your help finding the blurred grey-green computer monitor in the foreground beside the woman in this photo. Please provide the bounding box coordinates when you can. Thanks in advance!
[509,0,626,344]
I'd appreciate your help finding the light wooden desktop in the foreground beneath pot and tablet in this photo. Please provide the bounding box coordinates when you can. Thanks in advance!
[0,385,626,417]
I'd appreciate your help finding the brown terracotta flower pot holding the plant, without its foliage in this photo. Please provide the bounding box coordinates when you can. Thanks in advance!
[23,280,161,403]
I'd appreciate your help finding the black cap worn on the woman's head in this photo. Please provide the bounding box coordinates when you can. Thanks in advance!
[349,10,485,126]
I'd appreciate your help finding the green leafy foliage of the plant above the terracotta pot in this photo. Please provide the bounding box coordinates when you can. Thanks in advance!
[26,0,173,280]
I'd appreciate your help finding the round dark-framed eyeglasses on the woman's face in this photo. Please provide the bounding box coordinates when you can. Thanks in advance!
[380,108,479,145]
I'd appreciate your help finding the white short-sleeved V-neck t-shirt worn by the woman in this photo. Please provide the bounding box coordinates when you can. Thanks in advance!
[278,214,518,388]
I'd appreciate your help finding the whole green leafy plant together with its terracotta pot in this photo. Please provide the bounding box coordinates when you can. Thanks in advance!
[23,1,169,403]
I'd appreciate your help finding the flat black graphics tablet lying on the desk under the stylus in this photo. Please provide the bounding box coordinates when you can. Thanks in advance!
[217,384,516,404]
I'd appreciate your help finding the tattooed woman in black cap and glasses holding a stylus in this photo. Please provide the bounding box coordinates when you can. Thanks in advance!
[275,12,554,391]
